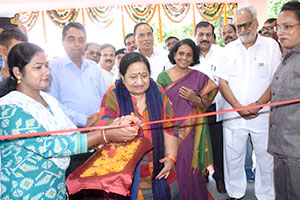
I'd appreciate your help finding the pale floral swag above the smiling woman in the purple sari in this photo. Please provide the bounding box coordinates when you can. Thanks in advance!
[162,3,191,23]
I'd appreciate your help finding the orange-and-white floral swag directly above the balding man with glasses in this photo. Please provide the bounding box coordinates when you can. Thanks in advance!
[124,4,157,23]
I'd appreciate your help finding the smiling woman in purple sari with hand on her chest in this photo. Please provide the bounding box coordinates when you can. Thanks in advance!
[157,39,217,200]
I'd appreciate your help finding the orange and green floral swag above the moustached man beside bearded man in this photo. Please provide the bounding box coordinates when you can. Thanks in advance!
[195,3,226,22]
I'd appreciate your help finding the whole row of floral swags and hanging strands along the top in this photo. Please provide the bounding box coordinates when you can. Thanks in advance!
[20,3,237,34]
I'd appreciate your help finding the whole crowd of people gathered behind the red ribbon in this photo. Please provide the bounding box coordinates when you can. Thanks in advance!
[0,1,300,200]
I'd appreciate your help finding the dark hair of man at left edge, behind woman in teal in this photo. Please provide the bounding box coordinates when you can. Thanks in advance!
[0,28,28,48]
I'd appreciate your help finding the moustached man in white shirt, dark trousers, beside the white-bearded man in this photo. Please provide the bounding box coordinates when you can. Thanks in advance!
[194,21,226,193]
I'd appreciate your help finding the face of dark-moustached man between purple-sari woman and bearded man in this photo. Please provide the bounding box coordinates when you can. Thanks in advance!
[195,26,214,51]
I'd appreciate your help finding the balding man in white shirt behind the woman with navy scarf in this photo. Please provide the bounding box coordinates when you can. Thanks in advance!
[133,22,172,81]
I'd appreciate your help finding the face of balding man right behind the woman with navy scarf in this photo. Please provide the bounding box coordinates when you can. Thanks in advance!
[135,24,154,50]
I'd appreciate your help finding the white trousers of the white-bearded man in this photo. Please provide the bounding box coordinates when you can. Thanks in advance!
[223,127,275,200]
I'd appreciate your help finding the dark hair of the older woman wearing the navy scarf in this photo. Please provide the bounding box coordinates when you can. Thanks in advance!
[120,52,151,76]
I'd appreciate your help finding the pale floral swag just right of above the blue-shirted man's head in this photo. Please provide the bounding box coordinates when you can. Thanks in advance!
[86,6,115,28]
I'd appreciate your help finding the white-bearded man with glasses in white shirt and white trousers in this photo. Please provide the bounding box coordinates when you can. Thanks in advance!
[216,7,281,200]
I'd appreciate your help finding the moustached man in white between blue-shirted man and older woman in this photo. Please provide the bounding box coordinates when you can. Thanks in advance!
[100,44,118,87]
